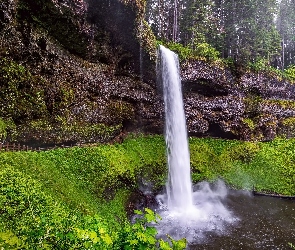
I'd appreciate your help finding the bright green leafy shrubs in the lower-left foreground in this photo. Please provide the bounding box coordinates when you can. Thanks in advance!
[0,165,186,250]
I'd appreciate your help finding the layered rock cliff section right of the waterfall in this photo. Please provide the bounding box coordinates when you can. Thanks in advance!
[182,61,295,140]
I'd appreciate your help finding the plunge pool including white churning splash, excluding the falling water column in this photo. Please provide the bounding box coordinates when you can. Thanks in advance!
[156,182,295,250]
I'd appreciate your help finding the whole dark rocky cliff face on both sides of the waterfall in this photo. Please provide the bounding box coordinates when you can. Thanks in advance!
[0,0,295,144]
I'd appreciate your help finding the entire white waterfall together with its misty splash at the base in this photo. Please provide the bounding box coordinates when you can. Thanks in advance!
[157,46,235,241]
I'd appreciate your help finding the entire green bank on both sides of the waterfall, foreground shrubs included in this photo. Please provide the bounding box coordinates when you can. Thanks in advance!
[0,136,295,249]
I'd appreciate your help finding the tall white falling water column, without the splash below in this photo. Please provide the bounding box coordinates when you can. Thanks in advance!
[158,46,193,211]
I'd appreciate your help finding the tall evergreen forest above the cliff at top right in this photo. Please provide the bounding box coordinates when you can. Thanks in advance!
[146,0,295,70]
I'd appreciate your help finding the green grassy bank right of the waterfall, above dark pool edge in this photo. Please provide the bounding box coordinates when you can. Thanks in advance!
[190,139,295,195]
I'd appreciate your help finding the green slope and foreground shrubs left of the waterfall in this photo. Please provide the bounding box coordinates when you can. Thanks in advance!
[0,144,186,249]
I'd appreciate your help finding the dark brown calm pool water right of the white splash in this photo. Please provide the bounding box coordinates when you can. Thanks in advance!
[189,191,295,250]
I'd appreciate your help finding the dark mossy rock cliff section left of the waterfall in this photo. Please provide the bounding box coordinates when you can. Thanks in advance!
[0,0,161,143]
